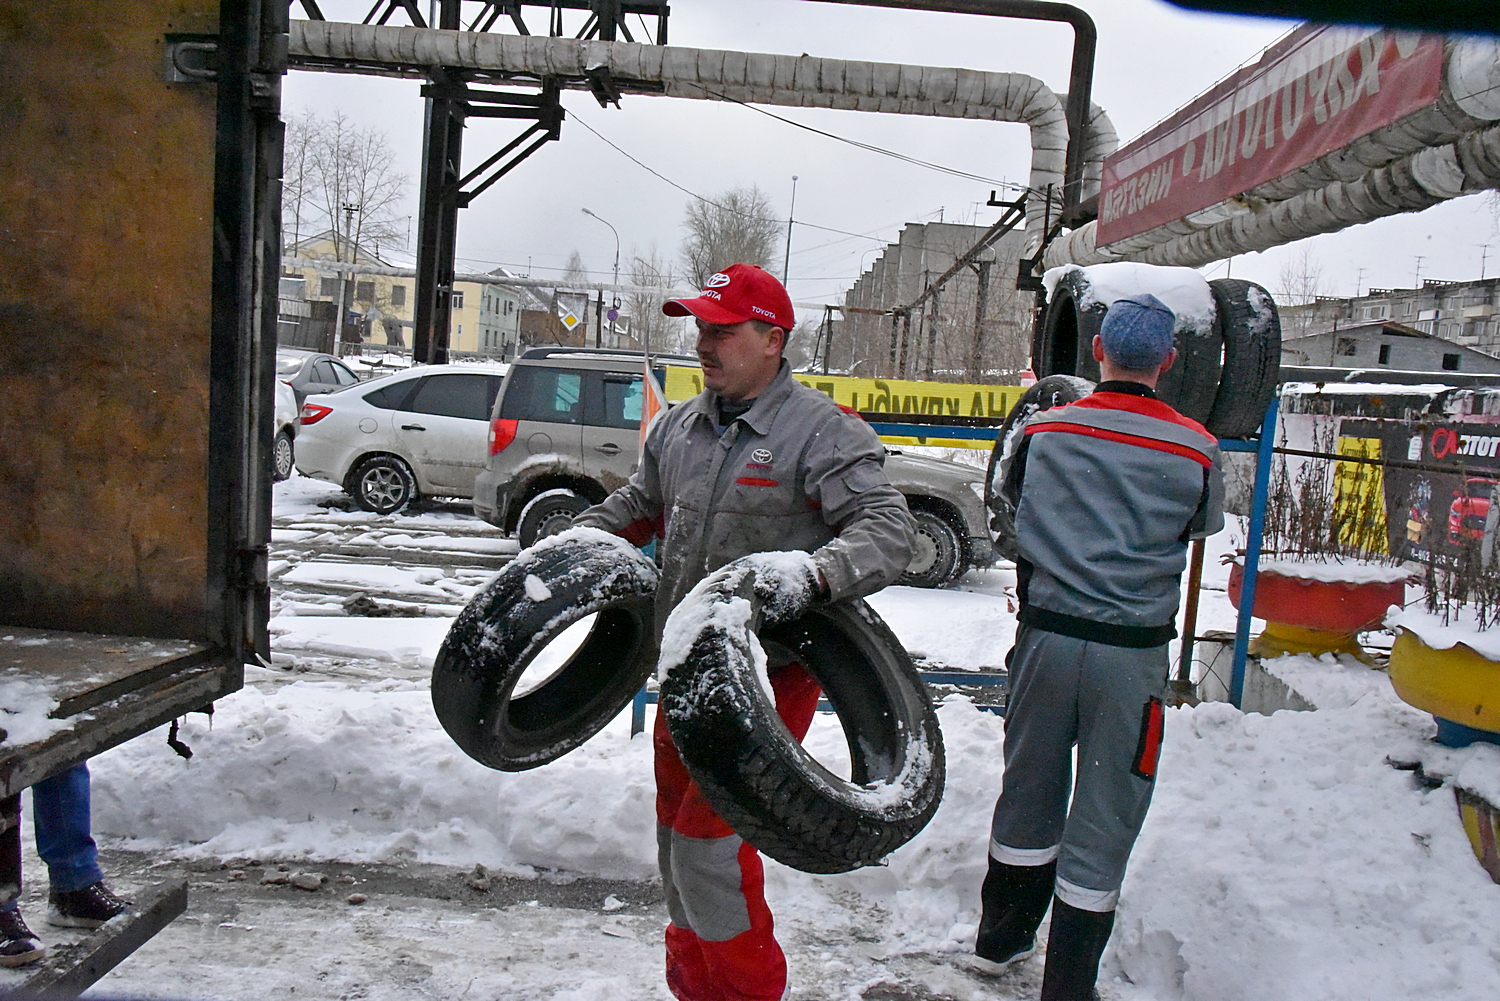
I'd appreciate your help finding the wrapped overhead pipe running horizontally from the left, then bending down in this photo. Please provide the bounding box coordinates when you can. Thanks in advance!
[288,21,1107,249]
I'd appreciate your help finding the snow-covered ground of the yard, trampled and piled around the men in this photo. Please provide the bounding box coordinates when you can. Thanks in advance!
[41,477,1500,1001]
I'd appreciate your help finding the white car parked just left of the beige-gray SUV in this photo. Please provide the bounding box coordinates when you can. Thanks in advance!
[297,365,506,515]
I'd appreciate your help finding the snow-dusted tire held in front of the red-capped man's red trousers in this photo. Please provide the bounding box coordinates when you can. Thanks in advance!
[662,554,944,872]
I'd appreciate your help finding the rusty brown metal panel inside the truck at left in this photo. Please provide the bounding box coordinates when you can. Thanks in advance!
[0,0,219,638]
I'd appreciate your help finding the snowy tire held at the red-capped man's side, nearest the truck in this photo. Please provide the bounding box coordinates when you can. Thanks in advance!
[432,528,657,771]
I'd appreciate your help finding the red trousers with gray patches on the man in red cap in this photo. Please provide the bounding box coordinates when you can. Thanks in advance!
[653,663,821,1001]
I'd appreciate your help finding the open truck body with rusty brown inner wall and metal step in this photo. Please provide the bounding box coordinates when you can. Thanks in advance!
[0,0,287,996]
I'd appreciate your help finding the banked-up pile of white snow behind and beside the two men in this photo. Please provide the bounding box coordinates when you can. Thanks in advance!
[95,672,1500,1001]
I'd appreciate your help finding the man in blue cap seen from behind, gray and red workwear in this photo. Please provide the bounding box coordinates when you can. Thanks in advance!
[974,294,1224,1001]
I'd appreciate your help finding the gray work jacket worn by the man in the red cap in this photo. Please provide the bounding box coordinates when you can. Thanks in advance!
[573,362,915,633]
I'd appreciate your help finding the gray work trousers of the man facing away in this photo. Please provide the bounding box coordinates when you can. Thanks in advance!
[990,626,1167,911]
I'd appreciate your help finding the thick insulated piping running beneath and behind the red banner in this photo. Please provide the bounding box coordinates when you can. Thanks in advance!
[1044,38,1500,267]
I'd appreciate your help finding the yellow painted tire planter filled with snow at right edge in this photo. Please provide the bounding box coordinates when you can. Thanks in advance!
[1391,629,1500,734]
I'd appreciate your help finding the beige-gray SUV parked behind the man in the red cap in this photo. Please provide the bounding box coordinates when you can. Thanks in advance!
[474,348,995,587]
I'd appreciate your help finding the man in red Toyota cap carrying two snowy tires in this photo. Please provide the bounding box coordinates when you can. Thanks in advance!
[573,264,914,1001]
